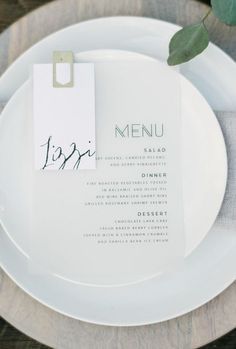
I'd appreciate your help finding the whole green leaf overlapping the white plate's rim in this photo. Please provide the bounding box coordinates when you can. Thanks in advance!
[167,22,208,65]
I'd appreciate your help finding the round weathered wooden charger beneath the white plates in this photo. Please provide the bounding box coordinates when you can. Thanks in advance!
[0,0,236,349]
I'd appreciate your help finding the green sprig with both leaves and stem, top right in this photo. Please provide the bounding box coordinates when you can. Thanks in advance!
[167,0,236,65]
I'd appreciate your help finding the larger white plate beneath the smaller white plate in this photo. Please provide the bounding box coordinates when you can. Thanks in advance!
[0,17,236,324]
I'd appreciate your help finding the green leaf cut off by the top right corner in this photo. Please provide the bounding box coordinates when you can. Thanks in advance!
[211,0,236,25]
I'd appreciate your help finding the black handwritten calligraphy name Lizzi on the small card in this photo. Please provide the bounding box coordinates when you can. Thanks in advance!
[41,136,95,170]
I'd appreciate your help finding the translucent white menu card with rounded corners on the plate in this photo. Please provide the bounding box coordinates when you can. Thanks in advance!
[30,61,185,286]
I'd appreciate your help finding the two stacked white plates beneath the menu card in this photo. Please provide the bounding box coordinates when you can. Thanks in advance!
[0,17,236,326]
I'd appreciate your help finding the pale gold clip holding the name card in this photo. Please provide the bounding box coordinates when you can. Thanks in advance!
[53,51,74,88]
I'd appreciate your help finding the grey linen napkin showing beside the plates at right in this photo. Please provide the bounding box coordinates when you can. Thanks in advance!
[0,102,236,228]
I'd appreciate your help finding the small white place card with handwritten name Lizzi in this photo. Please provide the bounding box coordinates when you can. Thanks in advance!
[33,63,96,170]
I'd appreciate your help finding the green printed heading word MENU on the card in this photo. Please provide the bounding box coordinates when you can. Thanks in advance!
[115,124,164,138]
